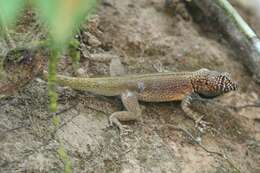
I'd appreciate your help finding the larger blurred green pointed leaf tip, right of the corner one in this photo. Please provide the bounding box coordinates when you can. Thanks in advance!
[34,0,96,46]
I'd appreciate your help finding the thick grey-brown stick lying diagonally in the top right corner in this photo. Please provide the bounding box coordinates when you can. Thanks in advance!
[192,0,260,83]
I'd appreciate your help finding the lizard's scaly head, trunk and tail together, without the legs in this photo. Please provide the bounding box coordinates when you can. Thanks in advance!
[45,69,237,99]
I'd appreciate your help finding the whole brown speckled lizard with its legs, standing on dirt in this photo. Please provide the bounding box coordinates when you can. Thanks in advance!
[43,68,238,131]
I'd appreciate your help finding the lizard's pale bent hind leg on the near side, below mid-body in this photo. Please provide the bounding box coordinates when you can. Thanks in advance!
[109,90,141,131]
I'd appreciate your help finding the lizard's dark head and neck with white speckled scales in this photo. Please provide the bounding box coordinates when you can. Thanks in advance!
[192,68,238,97]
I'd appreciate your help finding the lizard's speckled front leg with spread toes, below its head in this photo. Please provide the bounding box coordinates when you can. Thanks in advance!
[181,92,210,127]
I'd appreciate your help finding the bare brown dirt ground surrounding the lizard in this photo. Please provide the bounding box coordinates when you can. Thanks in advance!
[0,0,260,173]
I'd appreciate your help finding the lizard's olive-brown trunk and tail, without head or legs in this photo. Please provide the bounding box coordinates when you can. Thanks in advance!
[53,72,193,102]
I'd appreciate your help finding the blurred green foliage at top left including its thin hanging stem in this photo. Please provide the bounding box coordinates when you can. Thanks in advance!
[0,0,97,112]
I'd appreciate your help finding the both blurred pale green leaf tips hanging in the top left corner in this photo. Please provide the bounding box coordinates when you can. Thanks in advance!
[0,0,97,47]
